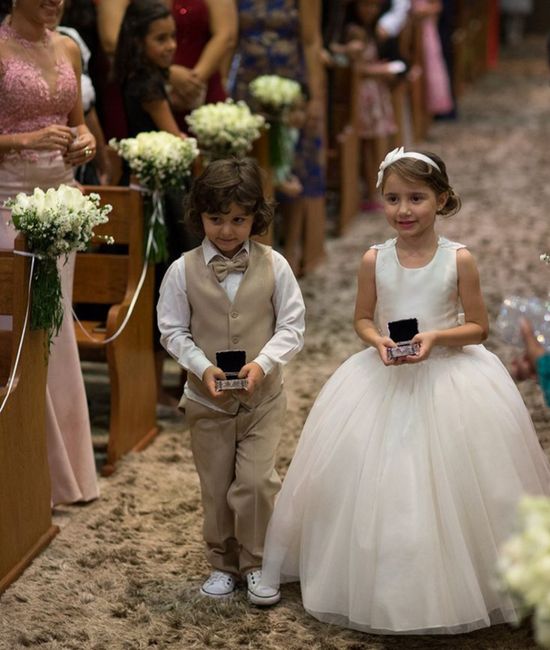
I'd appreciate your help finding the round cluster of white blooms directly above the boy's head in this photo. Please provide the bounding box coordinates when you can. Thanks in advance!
[185,99,265,160]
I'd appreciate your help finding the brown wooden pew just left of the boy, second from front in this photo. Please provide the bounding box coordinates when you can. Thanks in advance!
[73,186,158,475]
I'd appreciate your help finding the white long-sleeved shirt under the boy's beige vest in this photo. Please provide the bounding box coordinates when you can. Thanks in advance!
[157,238,305,407]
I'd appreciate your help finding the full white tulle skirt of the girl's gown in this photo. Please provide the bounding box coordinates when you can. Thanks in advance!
[263,345,550,634]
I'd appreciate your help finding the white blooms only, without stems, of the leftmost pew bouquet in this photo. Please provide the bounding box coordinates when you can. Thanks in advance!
[5,185,112,257]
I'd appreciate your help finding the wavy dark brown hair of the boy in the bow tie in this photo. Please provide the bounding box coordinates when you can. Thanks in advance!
[185,158,275,237]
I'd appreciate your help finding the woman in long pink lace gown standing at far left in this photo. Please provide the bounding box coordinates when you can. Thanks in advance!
[0,0,98,505]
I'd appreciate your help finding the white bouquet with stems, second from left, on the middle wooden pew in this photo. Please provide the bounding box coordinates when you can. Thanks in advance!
[109,131,199,263]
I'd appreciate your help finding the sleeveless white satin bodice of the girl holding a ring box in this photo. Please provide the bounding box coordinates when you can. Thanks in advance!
[373,237,464,334]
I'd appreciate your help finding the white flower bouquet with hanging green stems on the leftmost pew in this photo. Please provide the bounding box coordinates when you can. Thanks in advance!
[5,185,113,349]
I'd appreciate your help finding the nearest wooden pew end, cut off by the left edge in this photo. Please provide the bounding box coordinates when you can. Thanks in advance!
[0,236,58,593]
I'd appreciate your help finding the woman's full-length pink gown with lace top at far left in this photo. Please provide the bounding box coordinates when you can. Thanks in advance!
[0,24,98,505]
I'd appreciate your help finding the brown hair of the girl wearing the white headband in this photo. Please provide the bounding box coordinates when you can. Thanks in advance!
[382,149,462,217]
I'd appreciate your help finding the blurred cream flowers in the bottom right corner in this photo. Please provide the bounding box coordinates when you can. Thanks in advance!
[499,497,550,648]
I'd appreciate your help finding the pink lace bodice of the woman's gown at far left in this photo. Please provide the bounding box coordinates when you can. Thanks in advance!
[0,23,78,133]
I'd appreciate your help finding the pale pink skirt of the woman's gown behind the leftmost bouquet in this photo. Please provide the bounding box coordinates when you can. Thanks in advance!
[0,152,99,505]
